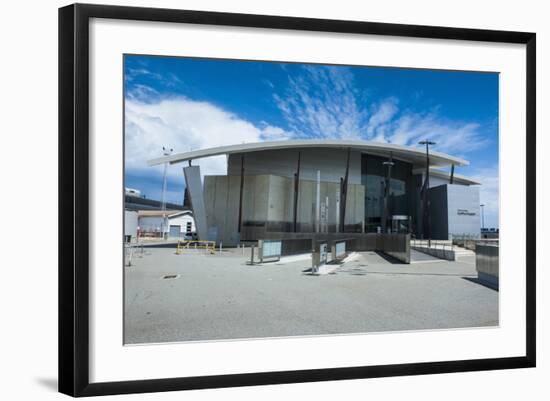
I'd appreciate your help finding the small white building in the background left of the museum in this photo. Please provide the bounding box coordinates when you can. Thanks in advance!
[137,210,196,238]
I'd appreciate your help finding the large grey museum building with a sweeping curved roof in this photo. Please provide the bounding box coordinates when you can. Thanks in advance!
[149,140,480,245]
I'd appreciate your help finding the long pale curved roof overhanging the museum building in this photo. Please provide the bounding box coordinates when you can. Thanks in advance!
[148,139,469,166]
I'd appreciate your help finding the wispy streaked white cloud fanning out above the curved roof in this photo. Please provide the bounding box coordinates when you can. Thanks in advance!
[273,66,489,154]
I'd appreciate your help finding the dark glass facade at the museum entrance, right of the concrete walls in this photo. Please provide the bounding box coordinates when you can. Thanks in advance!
[361,154,412,232]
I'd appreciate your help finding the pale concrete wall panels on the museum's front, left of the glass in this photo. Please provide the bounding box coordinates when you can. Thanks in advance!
[204,175,365,245]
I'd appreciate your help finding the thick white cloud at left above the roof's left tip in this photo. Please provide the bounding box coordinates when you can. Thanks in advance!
[125,97,289,178]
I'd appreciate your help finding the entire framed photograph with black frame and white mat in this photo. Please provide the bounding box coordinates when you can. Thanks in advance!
[59,4,536,396]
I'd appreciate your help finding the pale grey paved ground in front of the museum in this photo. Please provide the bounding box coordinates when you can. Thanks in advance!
[124,248,498,344]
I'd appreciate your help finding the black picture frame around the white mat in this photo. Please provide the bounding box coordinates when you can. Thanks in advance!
[59,4,536,396]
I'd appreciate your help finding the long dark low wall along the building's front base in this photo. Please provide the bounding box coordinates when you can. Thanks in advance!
[263,232,411,263]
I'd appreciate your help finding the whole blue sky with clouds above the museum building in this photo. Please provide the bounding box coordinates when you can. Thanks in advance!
[124,55,498,227]
